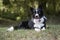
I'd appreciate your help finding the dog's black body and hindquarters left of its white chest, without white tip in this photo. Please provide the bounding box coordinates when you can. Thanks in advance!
[14,21,34,30]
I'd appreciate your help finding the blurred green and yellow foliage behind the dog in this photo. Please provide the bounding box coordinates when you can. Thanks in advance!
[0,0,60,21]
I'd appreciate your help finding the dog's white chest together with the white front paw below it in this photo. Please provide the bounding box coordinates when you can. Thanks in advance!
[34,18,44,31]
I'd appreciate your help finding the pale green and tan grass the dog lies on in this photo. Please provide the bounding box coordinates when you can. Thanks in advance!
[0,25,60,40]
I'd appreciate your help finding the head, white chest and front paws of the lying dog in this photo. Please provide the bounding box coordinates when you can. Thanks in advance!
[31,5,47,31]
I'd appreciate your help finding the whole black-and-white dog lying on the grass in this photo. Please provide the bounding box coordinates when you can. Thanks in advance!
[7,6,47,31]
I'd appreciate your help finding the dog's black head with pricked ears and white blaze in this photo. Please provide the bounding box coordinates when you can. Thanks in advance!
[31,5,43,19]
